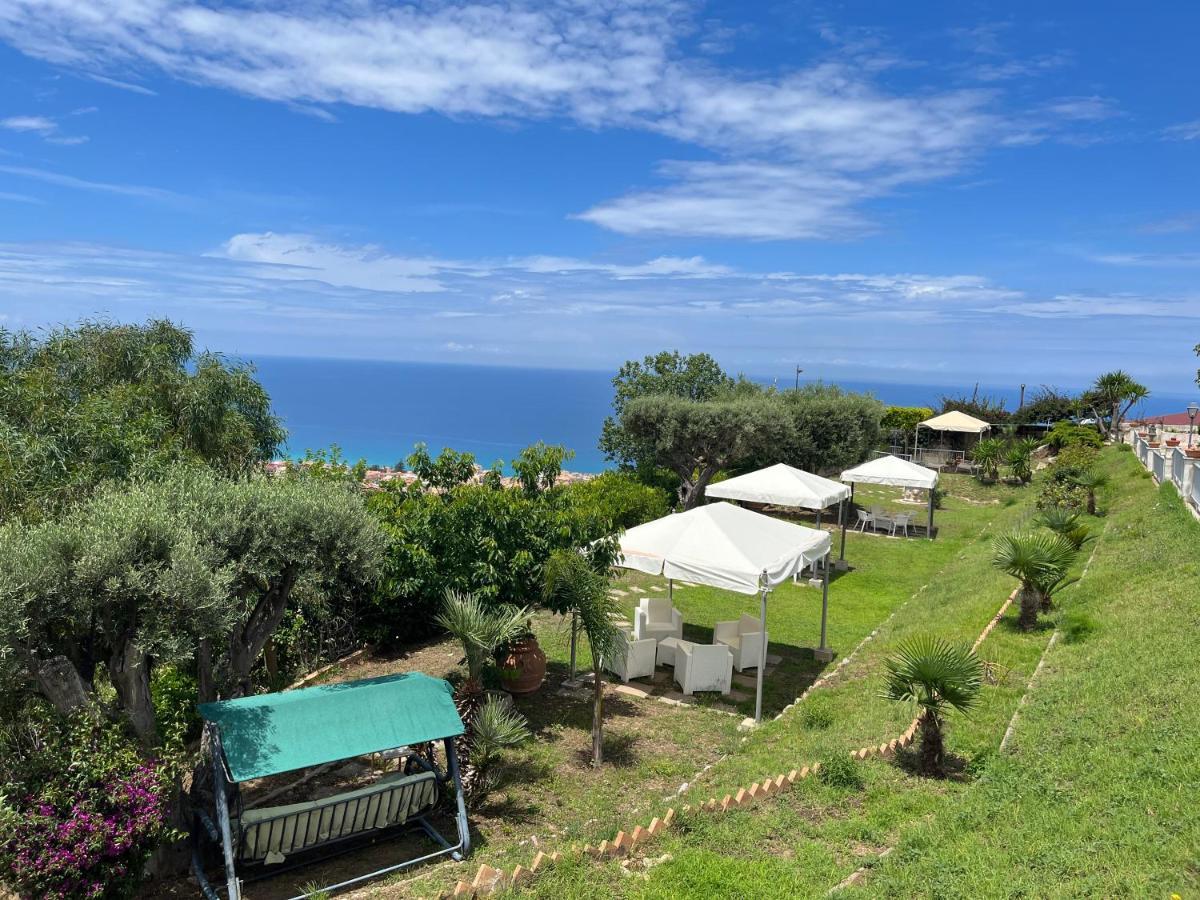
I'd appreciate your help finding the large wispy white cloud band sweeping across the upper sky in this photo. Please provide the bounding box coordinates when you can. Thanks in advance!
[0,0,1008,239]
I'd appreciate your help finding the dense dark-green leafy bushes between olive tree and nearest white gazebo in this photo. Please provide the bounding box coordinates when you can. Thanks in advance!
[367,454,628,642]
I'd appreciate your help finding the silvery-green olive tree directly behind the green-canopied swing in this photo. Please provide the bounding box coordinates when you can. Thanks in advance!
[0,469,385,744]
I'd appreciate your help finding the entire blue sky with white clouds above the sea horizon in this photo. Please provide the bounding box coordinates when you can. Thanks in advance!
[0,0,1200,395]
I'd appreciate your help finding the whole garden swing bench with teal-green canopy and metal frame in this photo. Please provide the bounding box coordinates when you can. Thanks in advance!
[192,672,470,900]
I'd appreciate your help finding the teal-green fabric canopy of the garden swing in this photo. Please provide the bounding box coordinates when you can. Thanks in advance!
[199,672,463,781]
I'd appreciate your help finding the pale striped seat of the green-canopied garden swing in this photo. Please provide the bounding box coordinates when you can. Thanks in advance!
[234,772,438,863]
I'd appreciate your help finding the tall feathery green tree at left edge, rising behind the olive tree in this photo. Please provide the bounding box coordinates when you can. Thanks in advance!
[0,320,284,521]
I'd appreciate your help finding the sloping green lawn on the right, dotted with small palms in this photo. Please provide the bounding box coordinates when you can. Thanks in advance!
[520,450,1200,898]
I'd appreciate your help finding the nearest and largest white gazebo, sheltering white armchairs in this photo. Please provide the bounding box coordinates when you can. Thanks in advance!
[617,503,833,721]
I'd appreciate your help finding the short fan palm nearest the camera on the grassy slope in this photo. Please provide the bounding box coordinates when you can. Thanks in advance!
[883,635,983,776]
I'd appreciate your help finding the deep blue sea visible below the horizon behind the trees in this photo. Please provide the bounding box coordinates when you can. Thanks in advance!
[254,356,1194,472]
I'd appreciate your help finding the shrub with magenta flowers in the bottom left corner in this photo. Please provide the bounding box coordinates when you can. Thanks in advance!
[0,706,169,900]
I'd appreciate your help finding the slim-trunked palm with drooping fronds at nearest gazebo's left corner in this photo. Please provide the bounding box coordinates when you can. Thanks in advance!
[542,550,625,768]
